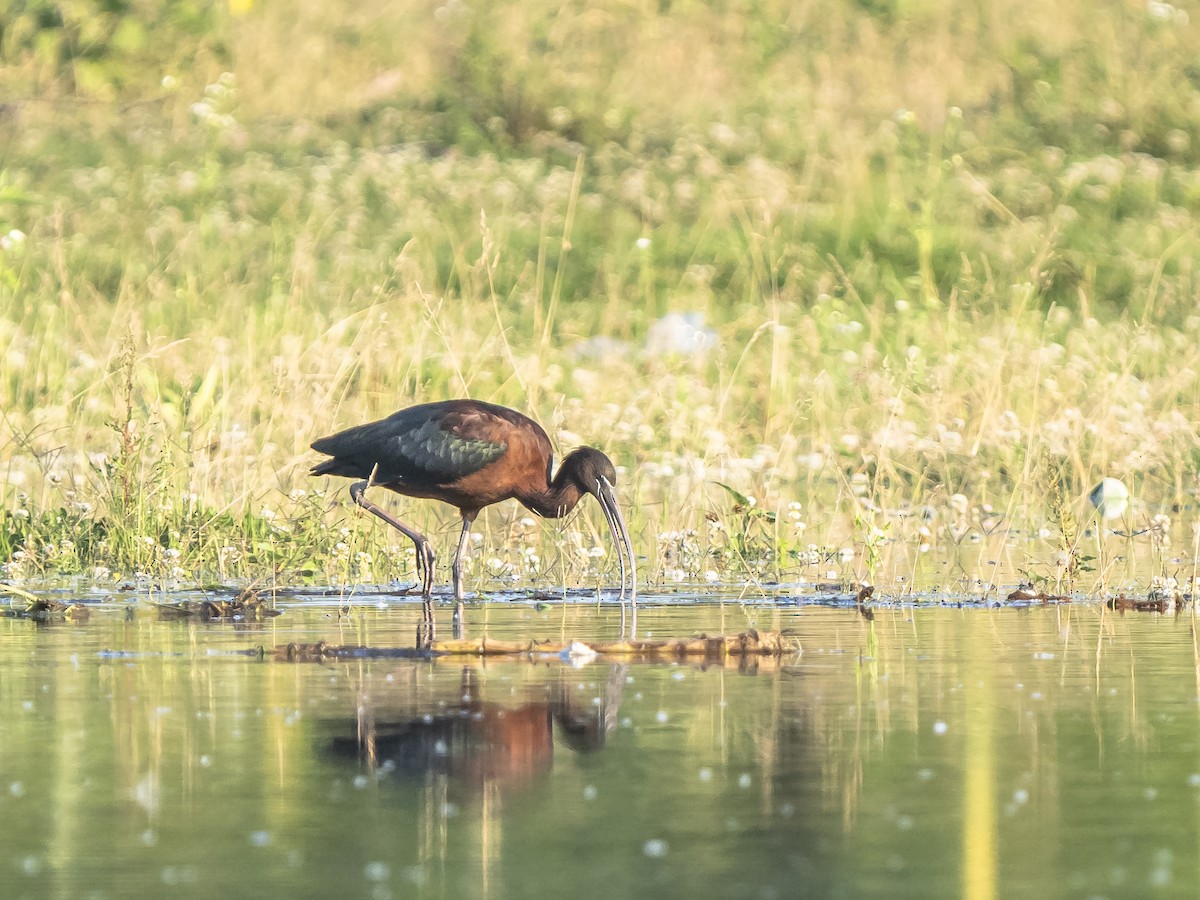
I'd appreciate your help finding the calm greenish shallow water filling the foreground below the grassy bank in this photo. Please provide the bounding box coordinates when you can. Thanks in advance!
[0,595,1200,898]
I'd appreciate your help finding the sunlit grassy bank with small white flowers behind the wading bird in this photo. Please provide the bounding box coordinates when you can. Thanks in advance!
[0,0,1200,595]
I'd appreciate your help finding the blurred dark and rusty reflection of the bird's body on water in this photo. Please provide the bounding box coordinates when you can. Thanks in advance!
[332,664,628,788]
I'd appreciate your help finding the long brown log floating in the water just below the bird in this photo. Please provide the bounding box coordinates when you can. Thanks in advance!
[268,630,800,661]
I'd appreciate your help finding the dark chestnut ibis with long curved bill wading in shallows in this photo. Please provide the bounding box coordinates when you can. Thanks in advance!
[311,400,637,640]
